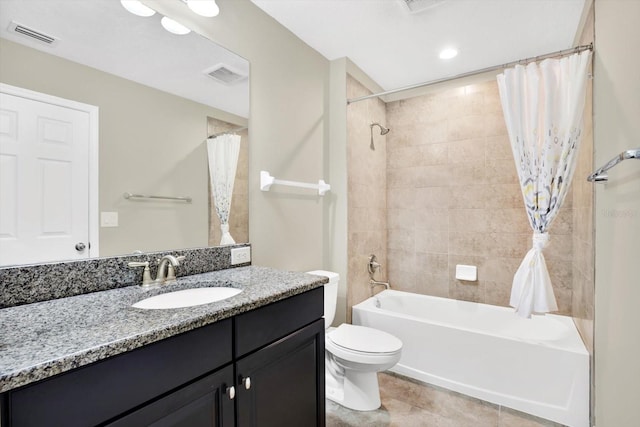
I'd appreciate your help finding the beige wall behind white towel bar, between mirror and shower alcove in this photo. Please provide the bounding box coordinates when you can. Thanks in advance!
[147,0,331,271]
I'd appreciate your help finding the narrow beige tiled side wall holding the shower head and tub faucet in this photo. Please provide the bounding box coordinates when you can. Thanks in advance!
[347,76,388,322]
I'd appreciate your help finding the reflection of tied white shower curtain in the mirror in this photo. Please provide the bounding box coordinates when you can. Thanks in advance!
[207,134,241,245]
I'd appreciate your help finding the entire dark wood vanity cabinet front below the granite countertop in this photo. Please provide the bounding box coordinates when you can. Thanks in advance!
[0,288,325,427]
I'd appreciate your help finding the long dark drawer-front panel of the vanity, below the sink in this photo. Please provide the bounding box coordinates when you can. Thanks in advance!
[2,319,233,427]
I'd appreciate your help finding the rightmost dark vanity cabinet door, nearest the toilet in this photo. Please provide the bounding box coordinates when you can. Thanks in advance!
[236,319,325,427]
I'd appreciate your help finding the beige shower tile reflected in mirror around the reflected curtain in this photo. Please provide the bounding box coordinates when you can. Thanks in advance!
[207,117,249,246]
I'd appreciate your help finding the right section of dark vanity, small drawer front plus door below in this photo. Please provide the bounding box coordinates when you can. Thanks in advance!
[234,288,325,427]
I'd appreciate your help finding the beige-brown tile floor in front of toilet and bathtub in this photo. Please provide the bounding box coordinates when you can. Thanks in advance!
[326,372,562,427]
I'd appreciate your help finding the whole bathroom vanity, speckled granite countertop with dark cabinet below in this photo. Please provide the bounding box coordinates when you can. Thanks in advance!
[0,266,325,427]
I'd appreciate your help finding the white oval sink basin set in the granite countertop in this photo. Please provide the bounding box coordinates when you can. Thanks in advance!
[133,287,242,310]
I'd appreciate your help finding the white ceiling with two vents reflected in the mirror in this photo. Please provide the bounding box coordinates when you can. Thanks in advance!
[0,0,249,117]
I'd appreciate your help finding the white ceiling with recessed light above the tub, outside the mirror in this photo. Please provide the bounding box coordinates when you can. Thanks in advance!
[251,0,584,90]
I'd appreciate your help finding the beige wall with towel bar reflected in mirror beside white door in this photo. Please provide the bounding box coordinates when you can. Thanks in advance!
[0,39,246,256]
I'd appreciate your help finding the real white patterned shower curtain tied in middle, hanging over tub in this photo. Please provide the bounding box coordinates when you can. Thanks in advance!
[498,51,591,317]
